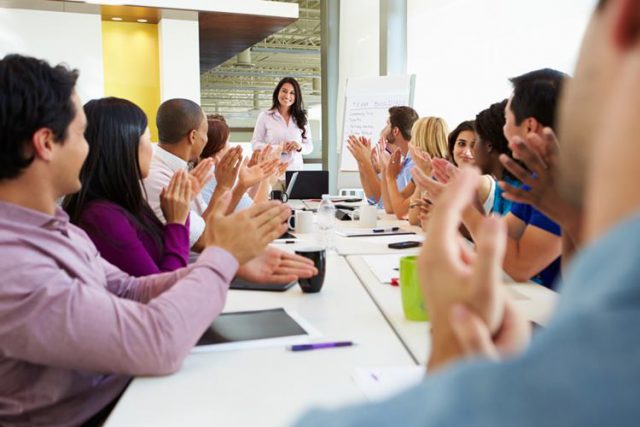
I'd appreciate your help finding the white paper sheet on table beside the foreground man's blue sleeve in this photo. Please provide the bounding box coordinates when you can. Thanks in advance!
[352,366,425,400]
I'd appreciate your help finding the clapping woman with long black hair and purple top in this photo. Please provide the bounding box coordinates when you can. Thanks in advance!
[63,98,191,276]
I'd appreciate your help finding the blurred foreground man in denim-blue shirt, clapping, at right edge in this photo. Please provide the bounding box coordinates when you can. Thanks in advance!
[300,0,640,427]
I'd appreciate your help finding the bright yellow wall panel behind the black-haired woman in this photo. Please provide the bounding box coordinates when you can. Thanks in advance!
[102,21,160,141]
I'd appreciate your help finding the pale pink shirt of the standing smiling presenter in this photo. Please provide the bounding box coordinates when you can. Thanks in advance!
[251,109,313,170]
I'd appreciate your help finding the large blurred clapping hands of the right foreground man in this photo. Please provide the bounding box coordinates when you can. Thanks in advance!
[419,169,530,369]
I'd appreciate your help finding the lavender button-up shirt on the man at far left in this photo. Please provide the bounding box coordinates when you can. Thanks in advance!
[0,202,238,427]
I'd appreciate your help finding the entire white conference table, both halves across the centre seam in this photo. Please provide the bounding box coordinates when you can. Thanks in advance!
[105,206,555,427]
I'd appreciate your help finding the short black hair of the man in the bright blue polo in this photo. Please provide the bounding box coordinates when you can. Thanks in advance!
[509,68,568,127]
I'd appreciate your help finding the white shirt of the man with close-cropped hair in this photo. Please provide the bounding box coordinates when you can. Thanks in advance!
[142,145,207,249]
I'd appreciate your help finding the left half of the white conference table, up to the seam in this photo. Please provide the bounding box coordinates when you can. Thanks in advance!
[106,253,415,427]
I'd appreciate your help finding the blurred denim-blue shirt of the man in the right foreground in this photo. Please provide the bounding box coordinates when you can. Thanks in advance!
[297,215,640,427]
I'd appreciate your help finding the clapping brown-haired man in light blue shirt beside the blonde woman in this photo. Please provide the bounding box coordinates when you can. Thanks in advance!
[347,106,418,213]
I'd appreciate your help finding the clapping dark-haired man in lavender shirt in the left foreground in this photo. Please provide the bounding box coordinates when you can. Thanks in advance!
[0,55,313,426]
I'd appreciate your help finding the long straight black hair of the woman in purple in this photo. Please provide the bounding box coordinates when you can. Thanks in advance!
[63,98,163,252]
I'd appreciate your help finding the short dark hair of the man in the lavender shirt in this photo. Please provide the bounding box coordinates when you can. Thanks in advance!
[0,55,78,180]
